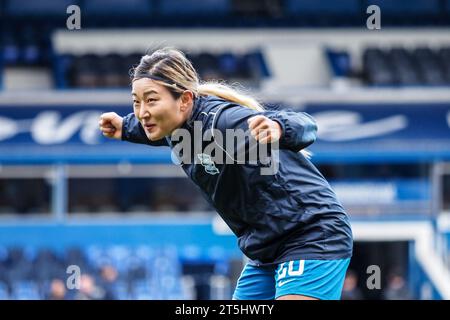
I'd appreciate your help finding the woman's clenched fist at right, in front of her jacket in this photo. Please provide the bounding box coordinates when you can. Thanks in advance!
[247,115,283,144]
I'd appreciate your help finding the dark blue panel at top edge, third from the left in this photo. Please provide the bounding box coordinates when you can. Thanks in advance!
[159,0,231,16]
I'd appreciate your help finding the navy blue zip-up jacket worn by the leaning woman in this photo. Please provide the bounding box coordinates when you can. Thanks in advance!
[122,96,353,265]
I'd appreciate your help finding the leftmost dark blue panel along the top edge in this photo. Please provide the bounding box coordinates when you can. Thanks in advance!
[5,0,80,16]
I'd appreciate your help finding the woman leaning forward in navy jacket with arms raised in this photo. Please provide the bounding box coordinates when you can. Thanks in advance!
[99,48,353,300]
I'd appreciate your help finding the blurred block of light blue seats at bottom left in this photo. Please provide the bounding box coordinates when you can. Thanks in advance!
[0,246,213,300]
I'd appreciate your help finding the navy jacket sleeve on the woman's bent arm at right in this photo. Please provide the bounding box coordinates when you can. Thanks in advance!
[263,110,317,152]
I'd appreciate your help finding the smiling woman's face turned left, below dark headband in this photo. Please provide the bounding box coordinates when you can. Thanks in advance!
[131,78,193,141]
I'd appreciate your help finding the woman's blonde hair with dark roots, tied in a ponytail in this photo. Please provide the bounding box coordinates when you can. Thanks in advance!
[132,47,311,158]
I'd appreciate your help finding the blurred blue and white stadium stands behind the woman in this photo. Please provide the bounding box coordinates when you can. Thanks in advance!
[0,0,450,299]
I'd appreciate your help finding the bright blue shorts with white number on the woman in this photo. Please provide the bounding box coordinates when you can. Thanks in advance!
[233,258,350,300]
